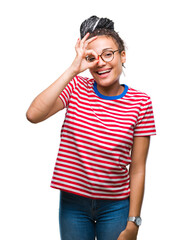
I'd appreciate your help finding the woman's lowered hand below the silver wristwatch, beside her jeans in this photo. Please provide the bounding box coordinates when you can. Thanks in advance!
[117,225,138,240]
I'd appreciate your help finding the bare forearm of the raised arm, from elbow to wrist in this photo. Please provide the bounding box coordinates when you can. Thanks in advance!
[26,68,76,123]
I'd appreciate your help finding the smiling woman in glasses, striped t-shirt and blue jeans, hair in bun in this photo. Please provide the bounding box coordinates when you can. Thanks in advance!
[27,16,155,240]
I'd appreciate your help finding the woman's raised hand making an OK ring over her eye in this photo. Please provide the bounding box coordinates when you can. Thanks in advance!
[71,33,98,75]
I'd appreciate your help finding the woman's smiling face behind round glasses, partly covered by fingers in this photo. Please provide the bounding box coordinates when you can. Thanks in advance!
[88,36,126,87]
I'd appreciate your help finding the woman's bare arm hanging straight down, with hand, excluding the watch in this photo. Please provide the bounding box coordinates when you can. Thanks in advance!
[118,136,150,240]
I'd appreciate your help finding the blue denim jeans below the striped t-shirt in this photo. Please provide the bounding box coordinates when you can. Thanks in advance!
[59,191,129,240]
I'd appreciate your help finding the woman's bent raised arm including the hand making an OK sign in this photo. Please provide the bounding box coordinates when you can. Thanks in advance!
[26,34,97,123]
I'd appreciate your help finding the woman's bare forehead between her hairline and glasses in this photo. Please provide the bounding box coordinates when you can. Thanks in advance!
[87,36,117,53]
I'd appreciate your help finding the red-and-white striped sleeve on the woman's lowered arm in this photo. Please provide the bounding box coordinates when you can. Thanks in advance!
[134,97,156,136]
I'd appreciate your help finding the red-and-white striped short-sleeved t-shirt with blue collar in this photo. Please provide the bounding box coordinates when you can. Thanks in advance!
[51,76,156,200]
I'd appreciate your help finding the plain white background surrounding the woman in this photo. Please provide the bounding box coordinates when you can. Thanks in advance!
[0,0,182,240]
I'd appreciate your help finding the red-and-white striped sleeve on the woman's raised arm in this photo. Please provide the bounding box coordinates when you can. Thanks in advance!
[59,76,78,108]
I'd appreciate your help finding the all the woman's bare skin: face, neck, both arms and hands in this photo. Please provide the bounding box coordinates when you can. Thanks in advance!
[26,34,150,240]
